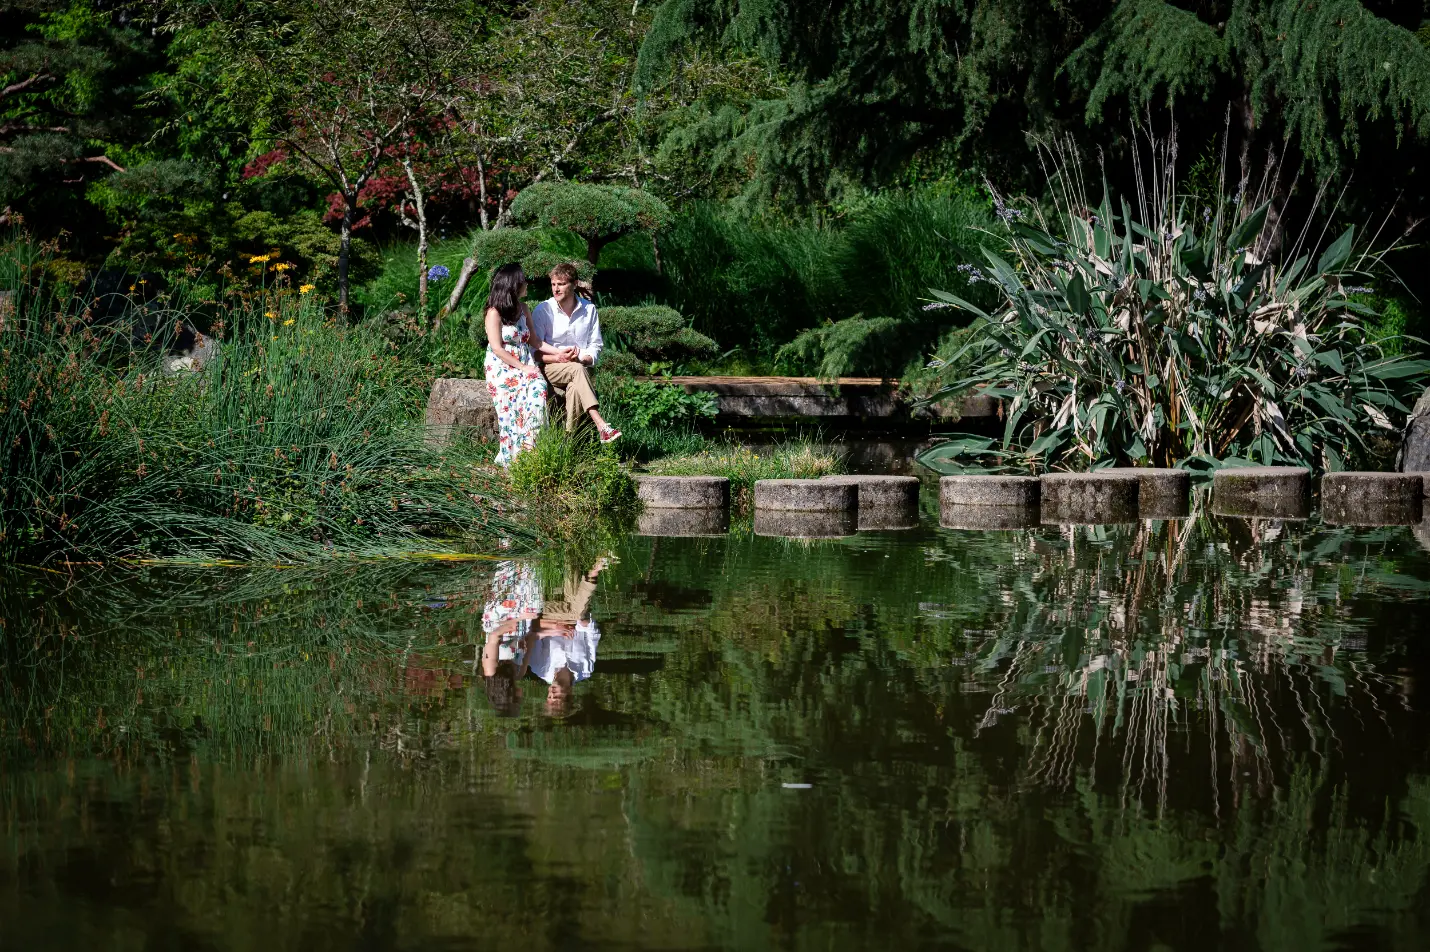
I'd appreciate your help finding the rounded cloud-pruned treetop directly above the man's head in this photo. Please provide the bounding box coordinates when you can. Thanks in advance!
[512,182,671,264]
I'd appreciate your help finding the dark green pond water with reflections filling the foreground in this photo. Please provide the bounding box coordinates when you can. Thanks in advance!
[0,513,1430,952]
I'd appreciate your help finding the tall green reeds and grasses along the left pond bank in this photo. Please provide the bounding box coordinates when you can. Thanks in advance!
[0,232,525,562]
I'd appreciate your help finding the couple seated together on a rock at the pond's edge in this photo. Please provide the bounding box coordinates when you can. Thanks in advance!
[485,264,621,466]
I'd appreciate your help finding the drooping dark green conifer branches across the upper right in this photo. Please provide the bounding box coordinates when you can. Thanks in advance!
[636,0,1430,230]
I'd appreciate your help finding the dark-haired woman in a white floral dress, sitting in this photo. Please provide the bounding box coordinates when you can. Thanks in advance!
[485,264,546,466]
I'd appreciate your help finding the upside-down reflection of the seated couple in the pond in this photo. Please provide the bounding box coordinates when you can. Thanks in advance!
[482,559,609,718]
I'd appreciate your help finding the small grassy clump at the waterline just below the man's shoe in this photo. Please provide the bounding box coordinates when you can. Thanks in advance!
[509,425,636,539]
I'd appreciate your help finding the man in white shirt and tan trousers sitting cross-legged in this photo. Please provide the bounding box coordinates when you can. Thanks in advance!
[532,264,621,443]
